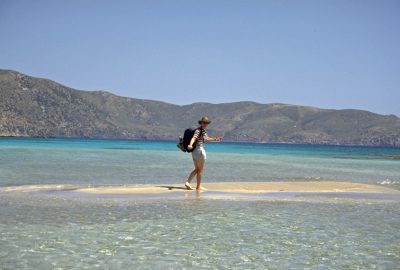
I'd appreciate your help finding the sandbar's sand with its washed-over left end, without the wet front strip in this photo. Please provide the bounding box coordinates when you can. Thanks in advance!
[0,181,400,195]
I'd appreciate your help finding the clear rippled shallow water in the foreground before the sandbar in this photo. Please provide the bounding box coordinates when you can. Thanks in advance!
[0,191,400,269]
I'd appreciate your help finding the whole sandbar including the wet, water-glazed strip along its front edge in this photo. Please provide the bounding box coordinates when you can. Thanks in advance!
[0,181,400,202]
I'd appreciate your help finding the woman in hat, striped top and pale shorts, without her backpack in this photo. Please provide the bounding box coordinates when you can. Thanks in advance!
[185,116,223,190]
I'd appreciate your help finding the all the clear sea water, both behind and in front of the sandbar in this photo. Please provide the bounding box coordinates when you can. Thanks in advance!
[0,138,400,269]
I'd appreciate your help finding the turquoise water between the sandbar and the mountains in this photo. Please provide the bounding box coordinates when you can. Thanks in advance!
[0,139,400,186]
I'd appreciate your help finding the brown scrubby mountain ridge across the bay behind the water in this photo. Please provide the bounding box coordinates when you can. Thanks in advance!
[0,70,400,146]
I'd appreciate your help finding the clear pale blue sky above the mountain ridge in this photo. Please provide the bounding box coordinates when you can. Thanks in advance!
[0,0,400,116]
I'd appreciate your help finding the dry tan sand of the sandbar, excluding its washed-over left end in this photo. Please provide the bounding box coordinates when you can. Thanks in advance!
[74,181,400,194]
